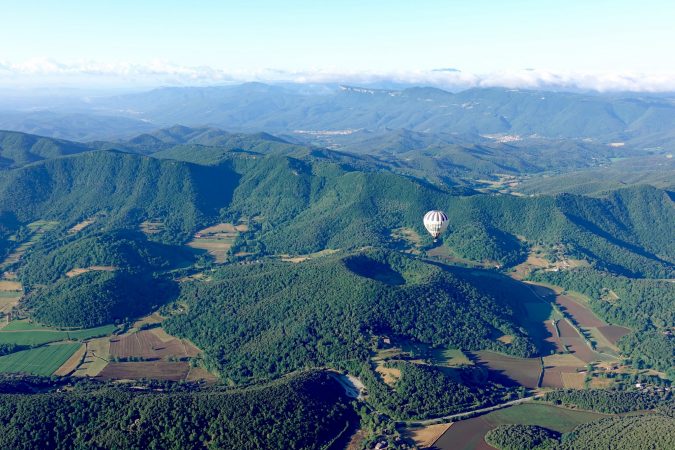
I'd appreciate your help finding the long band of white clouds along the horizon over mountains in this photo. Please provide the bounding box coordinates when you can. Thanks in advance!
[0,59,675,92]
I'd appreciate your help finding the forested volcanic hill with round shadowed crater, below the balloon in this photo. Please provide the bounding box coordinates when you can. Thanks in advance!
[164,250,537,382]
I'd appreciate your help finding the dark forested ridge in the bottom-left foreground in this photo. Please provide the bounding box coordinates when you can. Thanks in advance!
[0,373,354,450]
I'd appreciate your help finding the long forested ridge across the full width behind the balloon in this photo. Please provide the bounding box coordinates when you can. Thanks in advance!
[0,151,675,278]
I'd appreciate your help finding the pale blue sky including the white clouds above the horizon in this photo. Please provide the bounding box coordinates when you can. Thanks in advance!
[0,0,675,90]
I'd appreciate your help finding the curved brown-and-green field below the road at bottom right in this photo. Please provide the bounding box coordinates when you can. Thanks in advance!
[434,403,608,450]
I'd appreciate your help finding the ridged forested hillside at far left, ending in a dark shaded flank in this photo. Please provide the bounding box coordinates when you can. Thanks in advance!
[0,151,238,242]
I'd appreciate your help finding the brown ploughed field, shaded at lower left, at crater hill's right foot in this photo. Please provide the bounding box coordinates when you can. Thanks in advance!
[471,350,542,389]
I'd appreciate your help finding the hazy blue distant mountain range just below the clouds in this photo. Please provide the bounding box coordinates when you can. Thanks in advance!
[86,83,675,141]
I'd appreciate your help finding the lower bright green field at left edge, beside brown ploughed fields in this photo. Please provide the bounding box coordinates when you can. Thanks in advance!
[0,344,82,376]
